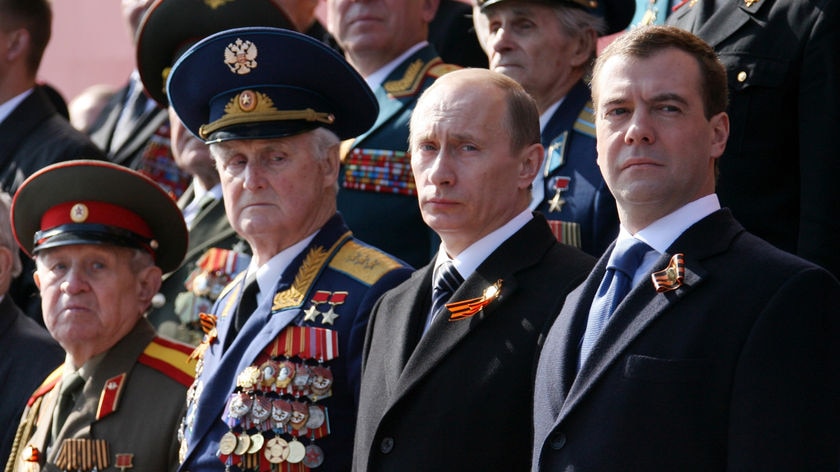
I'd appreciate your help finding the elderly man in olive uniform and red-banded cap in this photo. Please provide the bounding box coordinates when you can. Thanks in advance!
[6,161,193,472]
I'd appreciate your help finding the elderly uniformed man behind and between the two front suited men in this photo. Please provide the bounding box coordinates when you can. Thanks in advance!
[474,0,635,257]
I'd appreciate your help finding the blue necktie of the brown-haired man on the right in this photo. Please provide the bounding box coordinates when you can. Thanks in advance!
[578,238,651,369]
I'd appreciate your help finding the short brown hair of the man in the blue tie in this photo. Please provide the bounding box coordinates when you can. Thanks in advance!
[591,25,729,119]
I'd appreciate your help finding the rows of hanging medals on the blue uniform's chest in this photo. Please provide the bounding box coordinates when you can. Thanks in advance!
[218,327,337,472]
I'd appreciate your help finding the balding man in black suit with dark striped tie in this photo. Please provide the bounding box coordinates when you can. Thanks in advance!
[353,69,594,472]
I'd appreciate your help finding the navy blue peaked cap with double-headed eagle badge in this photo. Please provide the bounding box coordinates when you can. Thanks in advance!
[167,27,379,144]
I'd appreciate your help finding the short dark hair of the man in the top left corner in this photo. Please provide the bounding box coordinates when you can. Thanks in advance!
[0,0,52,74]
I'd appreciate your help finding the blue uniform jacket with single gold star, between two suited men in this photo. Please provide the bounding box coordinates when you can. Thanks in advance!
[537,81,618,257]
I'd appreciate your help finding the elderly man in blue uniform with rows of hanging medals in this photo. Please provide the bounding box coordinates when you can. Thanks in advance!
[168,28,410,472]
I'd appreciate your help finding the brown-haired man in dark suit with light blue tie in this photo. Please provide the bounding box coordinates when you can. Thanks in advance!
[533,26,840,471]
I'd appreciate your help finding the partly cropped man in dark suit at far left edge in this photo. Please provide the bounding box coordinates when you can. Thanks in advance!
[0,192,64,464]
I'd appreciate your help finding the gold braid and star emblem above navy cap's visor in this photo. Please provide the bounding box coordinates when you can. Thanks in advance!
[198,90,335,139]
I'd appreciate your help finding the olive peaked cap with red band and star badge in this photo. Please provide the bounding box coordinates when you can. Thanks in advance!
[11,160,187,272]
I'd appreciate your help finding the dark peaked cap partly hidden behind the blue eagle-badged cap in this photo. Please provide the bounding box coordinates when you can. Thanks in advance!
[136,0,294,107]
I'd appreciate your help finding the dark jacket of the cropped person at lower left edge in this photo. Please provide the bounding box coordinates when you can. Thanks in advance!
[0,296,64,464]
